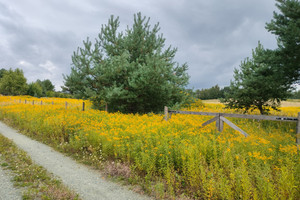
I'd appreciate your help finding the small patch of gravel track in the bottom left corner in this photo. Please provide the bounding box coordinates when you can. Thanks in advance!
[0,167,22,200]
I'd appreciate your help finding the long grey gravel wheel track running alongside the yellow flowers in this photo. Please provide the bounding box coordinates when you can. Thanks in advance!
[0,122,150,200]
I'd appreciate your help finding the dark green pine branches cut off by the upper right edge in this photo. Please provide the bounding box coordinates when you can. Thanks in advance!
[266,0,300,86]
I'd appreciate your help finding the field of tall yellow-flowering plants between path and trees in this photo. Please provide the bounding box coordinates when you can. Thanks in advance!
[0,96,300,199]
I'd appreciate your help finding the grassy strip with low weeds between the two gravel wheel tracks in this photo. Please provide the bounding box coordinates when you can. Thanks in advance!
[0,134,79,200]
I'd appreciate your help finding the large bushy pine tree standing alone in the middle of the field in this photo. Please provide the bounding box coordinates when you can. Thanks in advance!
[63,13,189,113]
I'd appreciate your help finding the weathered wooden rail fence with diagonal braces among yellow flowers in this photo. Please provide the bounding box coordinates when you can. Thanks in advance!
[164,106,300,149]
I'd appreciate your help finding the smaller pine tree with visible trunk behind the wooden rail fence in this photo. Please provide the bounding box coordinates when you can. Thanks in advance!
[222,43,288,114]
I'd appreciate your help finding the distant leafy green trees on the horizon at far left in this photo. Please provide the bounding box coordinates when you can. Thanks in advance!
[0,68,69,97]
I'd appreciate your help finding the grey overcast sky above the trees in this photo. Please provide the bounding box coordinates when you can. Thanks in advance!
[0,0,276,90]
